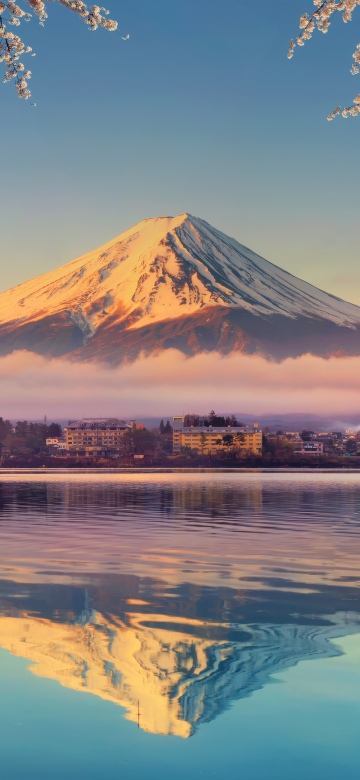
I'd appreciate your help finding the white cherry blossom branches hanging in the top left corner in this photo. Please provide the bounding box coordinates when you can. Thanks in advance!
[0,0,120,100]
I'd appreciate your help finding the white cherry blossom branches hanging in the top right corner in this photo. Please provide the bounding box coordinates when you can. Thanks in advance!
[288,0,360,121]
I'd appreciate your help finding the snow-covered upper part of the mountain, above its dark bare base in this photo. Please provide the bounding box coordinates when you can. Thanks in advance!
[0,213,360,362]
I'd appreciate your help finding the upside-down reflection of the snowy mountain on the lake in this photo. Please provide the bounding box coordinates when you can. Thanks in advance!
[0,576,360,737]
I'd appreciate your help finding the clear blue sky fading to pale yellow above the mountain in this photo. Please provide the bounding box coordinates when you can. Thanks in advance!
[0,0,360,304]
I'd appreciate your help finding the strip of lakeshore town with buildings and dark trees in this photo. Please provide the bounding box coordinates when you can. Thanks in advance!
[0,410,360,468]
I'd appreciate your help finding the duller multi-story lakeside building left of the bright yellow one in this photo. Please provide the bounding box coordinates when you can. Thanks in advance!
[65,417,135,455]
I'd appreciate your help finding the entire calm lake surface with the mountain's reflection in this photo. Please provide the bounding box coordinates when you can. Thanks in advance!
[0,473,360,780]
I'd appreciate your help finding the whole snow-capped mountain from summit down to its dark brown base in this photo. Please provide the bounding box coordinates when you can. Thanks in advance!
[0,214,360,365]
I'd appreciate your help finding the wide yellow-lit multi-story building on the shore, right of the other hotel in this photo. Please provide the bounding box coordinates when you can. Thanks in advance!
[173,417,262,455]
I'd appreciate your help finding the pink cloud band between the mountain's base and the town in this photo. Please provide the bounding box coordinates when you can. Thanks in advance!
[0,350,360,418]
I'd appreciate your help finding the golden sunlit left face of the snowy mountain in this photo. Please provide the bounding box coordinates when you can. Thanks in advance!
[0,214,202,336]
